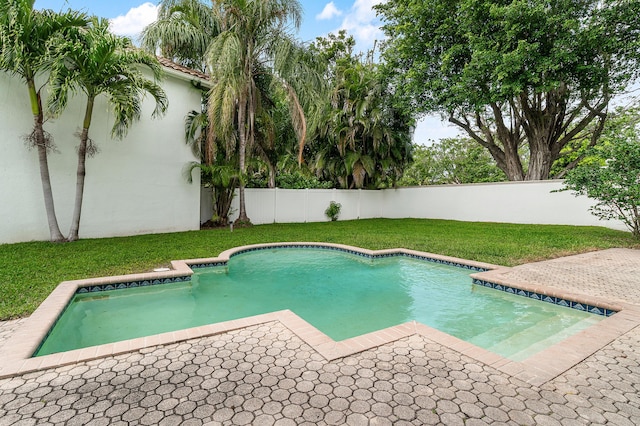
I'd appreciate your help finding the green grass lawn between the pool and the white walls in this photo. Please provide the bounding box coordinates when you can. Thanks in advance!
[0,219,640,320]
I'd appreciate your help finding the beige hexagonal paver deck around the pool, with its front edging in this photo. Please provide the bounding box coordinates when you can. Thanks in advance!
[0,249,640,426]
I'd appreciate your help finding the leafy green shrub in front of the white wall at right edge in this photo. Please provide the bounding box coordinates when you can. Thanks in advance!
[564,110,640,239]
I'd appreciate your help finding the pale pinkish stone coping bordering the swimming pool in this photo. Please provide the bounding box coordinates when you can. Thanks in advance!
[0,242,640,386]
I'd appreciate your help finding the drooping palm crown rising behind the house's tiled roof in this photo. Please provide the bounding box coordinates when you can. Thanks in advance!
[141,0,219,72]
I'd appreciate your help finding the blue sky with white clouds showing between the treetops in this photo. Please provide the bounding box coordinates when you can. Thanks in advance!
[35,0,459,145]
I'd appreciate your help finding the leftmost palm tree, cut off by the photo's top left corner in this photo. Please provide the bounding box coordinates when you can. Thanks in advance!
[0,0,87,241]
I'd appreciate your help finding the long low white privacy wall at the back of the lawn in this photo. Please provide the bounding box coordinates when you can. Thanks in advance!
[209,180,626,230]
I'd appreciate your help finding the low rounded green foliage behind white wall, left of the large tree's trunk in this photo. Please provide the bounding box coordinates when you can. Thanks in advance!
[399,138,506,186]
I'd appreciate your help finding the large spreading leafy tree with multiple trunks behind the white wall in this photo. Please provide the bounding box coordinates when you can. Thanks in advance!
[376,0,640,180]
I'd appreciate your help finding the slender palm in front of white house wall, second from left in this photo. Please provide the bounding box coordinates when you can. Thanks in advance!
[48,18,167,241]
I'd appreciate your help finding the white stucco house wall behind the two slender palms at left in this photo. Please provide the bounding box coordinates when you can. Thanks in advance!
[0,68,200,243]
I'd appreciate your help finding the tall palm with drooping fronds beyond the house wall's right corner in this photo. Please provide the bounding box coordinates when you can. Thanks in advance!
[207,0,312,222]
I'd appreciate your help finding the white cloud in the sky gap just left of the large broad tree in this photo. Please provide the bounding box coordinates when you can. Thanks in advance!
[339,0,386,50]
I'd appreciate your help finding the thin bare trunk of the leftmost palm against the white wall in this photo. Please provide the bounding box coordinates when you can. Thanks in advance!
[27,80,65,242]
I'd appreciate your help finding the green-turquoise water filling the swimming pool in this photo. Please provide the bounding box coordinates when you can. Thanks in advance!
[36,248,604,360]
